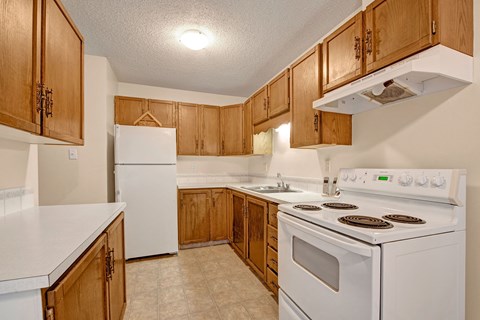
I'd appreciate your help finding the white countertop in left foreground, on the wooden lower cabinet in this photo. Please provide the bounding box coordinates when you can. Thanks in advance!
[0,202,126,294]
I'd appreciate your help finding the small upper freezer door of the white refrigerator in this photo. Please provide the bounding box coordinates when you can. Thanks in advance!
[115,125,177,164]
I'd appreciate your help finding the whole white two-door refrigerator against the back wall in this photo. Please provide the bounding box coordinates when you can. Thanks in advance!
[115,125,178,259]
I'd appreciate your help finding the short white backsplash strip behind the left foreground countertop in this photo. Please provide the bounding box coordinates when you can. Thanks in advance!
[0,187,35,217]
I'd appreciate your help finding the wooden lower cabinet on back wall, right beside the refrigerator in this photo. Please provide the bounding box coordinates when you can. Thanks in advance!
[178,189,228,245]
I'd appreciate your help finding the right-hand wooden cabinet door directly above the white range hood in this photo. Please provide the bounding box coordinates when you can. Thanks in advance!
[365,0,433,72]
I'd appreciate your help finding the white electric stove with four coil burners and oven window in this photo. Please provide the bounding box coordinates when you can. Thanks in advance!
[278,169,466,320]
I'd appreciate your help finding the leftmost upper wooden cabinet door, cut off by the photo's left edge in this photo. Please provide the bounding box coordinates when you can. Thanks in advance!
[0,0,41,134]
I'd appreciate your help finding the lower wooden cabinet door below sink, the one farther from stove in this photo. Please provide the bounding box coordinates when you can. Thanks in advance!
[232,191,247,258]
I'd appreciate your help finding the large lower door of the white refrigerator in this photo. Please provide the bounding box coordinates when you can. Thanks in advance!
[115,165,178,259]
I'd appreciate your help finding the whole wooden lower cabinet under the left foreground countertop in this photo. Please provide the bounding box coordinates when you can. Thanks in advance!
[46,213,126,320]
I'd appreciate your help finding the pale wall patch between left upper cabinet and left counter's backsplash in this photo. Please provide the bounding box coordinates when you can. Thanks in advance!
[0,137,38,203]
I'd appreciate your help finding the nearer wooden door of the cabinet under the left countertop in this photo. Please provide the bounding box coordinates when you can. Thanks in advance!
[46,234,109,320]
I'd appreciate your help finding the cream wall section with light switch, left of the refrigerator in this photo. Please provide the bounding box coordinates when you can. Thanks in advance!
[39,55,117,205]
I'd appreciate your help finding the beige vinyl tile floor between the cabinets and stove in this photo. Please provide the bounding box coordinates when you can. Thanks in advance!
[124,245,278,320]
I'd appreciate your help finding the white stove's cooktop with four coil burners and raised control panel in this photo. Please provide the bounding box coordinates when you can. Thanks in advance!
[279,169,465,244]
